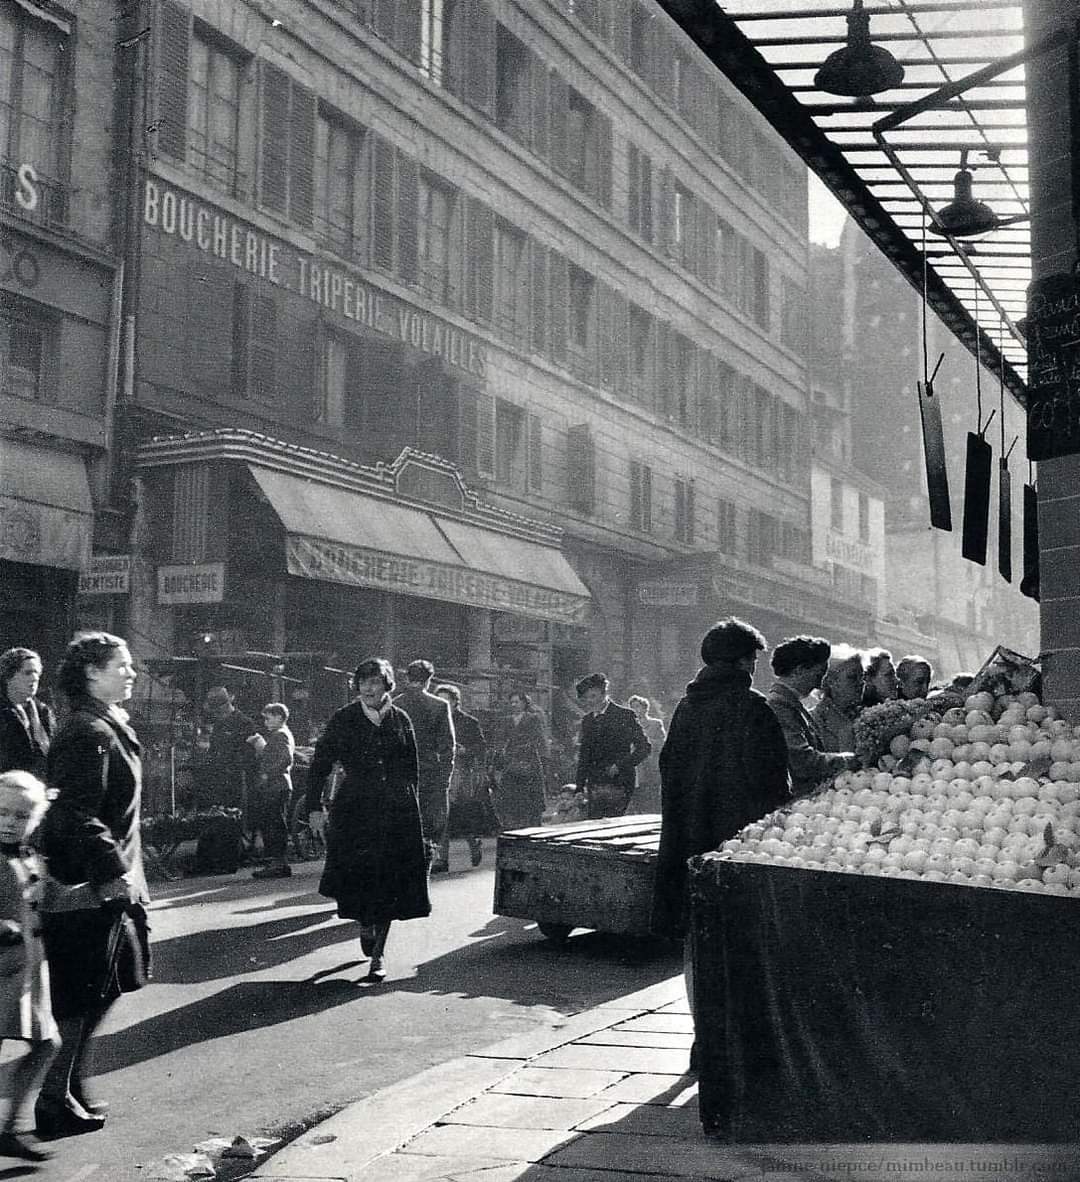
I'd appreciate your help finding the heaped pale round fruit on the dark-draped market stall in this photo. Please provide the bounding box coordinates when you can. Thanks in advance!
[721,694,1080,898]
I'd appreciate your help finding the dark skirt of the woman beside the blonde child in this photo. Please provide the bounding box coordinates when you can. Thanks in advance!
[41,908,132,1020]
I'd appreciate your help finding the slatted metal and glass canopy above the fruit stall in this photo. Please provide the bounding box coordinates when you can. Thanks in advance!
[657,0,1030,402]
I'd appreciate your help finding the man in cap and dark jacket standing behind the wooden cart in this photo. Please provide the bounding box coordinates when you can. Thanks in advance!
[574,673,652,820]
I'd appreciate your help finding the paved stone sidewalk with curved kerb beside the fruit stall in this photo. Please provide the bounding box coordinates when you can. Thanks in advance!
[249,976,1080,1182]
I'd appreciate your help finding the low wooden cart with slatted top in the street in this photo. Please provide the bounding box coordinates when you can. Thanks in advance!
[494,813,661,940]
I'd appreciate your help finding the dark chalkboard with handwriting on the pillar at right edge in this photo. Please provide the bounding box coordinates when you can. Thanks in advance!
[1024,274,1080,460]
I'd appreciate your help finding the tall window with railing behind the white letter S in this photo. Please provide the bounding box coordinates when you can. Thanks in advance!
[0,4,67,222]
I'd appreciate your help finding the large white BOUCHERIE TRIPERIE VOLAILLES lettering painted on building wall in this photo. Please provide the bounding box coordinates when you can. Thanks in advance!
[143,177,488,377]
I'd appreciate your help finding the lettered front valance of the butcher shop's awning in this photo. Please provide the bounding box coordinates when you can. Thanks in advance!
[285,534,588,624]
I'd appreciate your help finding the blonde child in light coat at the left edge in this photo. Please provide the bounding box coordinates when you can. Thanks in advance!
[0,772,60,1162]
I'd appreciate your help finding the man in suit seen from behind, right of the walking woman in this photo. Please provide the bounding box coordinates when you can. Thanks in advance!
[396,661,454,875]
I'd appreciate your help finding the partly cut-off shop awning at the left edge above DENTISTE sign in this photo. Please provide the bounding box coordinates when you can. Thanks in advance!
[0,440,93,571]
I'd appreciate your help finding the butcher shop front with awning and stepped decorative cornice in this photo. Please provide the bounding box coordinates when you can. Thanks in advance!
[138,430,590,736]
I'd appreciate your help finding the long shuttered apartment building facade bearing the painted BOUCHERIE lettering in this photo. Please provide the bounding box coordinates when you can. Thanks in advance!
[118,0,850,718]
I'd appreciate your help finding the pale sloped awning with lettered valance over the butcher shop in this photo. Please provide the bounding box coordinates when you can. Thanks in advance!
[248,463,590,624]
